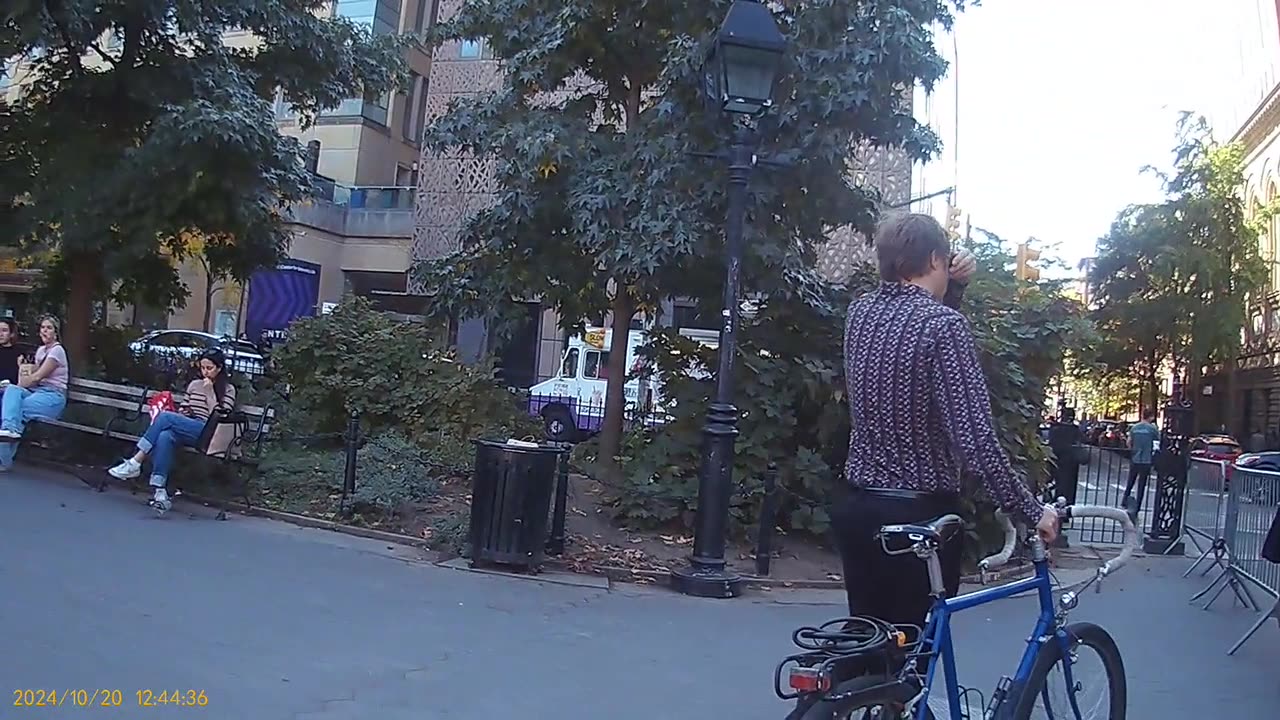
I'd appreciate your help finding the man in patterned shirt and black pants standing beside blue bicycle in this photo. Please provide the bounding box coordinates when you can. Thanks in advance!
[832,214,1057,626]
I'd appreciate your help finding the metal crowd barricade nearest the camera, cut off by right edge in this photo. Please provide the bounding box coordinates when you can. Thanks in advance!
[1210,466,1280,655]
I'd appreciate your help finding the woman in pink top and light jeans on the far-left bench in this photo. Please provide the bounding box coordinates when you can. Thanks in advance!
[0,315,70,471]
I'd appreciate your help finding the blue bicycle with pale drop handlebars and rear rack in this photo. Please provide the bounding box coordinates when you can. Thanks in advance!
[774,500,1138,720]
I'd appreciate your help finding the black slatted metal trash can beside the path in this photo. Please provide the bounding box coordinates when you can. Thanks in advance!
[470,439,562,569]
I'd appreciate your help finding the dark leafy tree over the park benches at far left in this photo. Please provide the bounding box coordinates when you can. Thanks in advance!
[0,0,402,354]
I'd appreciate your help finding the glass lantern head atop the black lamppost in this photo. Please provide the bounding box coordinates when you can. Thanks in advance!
[703,0,787,115]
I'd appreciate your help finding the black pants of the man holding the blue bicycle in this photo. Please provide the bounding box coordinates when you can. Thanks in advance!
[831,491,964,628]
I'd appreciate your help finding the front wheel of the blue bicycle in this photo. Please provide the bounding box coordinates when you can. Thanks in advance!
[1014,623,1129,720]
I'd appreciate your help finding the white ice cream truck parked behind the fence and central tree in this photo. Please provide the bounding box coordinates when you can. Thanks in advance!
[529,328,717,441]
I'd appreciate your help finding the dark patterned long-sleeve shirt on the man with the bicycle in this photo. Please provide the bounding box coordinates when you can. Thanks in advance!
[845,283,1043,525]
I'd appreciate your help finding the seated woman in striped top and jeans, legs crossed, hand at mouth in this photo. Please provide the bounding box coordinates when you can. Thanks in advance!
[108,348,236,515]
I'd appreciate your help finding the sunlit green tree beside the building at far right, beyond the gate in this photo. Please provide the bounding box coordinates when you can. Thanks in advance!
[1089,115,1267,407]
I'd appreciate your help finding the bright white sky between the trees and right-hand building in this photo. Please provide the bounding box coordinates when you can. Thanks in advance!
[915,0,1253,265]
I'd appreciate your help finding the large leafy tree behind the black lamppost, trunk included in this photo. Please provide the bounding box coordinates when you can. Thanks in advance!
[419,0,963,460]
